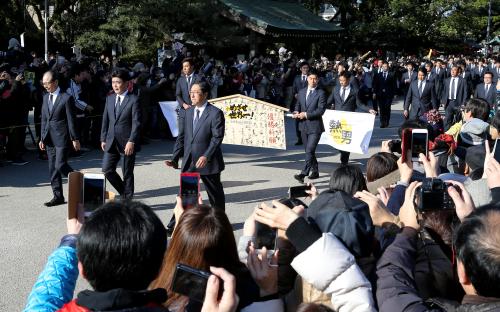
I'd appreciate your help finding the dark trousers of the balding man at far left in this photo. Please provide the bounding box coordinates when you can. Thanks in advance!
[46,146,73,198]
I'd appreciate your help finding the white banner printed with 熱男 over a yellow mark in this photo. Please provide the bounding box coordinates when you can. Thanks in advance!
[319,109,375,154]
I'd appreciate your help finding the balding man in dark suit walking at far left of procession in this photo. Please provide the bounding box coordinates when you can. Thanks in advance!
[39,71,80,207]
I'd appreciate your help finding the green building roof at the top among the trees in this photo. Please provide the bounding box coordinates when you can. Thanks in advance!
[220,0,342,37]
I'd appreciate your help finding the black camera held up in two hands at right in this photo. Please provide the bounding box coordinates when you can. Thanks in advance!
[414,178,460,212]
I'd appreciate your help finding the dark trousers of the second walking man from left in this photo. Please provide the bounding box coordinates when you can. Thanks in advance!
[102,143,135,199]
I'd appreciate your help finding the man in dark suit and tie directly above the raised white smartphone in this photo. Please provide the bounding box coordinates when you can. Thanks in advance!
[403,68,438,119]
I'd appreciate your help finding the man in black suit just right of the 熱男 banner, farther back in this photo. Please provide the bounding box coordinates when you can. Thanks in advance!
[373,61,396,128]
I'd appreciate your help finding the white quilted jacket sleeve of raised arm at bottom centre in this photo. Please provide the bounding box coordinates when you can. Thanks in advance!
[292,233,377,312]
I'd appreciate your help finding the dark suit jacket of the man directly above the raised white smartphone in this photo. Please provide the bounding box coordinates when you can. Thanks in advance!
[404,80,439,119]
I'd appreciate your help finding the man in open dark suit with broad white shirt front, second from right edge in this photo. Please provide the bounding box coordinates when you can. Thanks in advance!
[441,65,467,131]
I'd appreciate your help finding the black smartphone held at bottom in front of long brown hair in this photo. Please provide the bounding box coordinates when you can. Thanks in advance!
[172,263,211,302]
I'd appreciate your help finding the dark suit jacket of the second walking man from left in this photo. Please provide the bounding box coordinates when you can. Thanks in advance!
[101,93,141,152]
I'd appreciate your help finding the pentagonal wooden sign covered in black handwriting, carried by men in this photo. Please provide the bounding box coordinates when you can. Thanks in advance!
[209,94,288,150]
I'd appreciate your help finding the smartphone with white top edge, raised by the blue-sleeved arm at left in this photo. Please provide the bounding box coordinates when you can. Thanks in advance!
[82,173,106,217]
